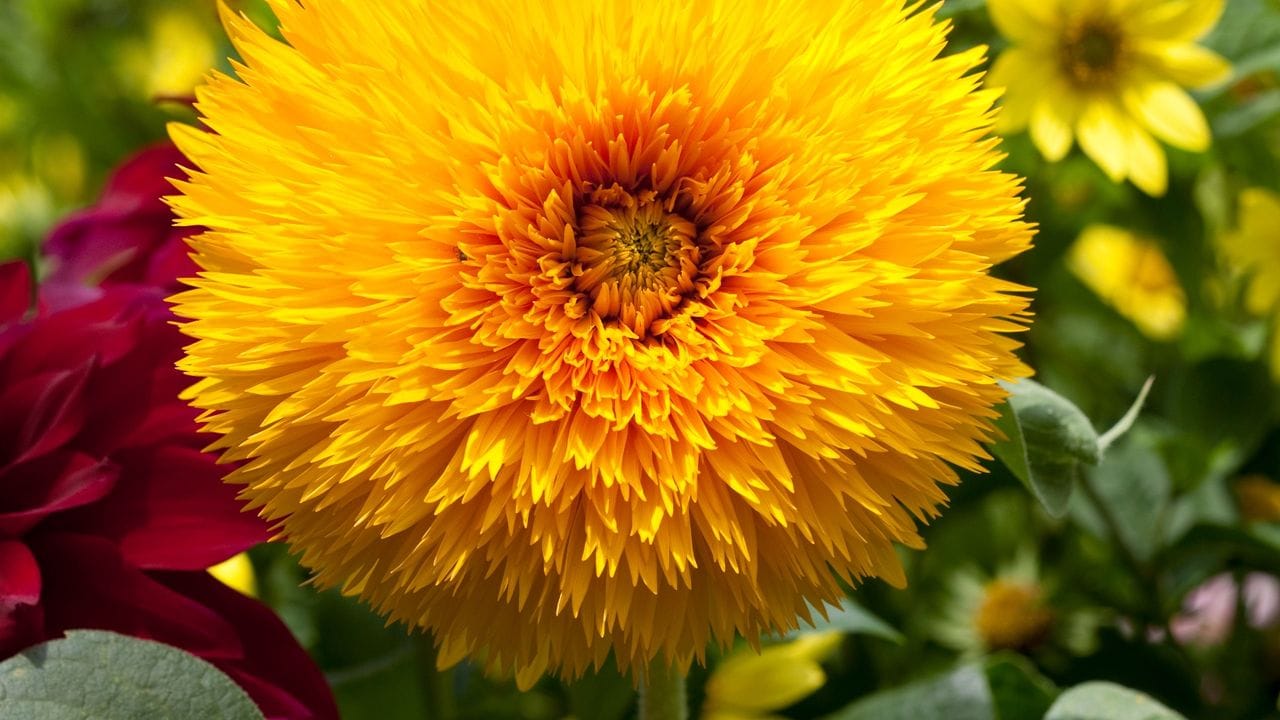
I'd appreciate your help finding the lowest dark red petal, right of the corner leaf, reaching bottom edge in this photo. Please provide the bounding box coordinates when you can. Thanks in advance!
[155,573,338,720]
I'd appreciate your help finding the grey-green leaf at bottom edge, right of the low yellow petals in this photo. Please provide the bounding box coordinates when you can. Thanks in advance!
[826,665,996,720]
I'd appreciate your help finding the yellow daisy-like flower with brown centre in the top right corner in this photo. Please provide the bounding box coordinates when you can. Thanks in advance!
[987,0,1231,195]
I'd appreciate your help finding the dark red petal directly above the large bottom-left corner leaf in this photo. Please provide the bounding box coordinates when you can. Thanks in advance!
[31,533,243,660]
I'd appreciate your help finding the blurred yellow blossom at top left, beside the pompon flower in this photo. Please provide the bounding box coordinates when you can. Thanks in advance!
[118,8,218,99]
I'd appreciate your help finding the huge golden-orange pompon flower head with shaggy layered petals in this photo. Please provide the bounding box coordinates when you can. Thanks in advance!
[173,0,1032,684]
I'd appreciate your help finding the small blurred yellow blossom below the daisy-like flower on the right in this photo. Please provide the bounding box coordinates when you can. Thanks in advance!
[1066,225,1187,341]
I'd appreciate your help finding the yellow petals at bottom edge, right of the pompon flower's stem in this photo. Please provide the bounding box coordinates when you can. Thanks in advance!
[701,630,844,720]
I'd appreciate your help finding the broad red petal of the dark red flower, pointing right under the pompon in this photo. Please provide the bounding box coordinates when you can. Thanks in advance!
[68,446,268,570]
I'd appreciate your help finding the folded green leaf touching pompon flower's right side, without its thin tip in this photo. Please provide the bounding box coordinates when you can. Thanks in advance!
[992,379,1100,518]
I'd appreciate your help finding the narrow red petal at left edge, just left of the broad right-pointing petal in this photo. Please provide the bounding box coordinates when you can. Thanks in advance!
[0,452,119,536]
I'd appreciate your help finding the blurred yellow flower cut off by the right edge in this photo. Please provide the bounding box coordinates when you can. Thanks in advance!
[1221,187,1280,378]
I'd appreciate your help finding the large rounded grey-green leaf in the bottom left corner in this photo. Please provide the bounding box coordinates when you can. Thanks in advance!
[0,630,262,720]
